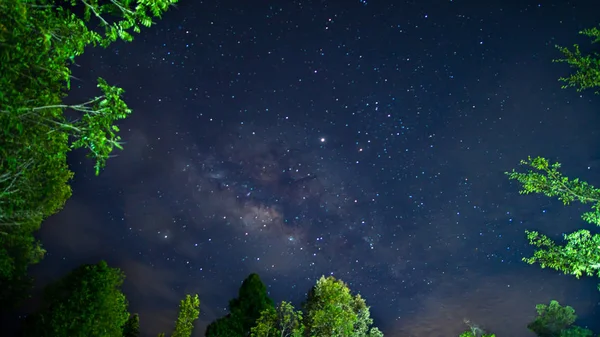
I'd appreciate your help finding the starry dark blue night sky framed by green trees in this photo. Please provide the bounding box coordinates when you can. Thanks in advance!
[28,0,600,337]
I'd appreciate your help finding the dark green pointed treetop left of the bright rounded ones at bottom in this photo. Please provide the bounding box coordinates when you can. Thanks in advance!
[206,273,273,337]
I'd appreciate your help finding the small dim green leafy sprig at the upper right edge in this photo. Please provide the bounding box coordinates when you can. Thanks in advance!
[554,27,600,94]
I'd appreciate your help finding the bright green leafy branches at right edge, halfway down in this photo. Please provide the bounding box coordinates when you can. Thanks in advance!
[506,157,600,289]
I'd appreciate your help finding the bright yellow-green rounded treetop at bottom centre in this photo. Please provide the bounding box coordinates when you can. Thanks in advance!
[303,276,383,337]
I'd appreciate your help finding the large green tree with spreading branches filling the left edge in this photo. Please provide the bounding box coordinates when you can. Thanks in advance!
[0,0,177,309]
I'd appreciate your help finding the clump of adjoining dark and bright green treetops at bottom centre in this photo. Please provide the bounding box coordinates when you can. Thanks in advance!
[206,274,383,337]
